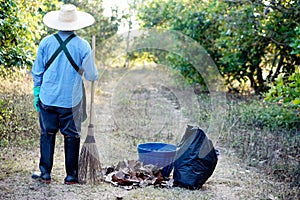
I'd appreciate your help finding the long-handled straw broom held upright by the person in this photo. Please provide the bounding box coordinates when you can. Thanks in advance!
[78,36,103,184]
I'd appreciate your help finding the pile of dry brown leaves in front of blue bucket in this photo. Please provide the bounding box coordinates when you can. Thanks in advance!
[103,160,173,190]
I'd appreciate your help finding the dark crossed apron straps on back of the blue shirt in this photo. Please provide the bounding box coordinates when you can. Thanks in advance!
[45,33,82,75]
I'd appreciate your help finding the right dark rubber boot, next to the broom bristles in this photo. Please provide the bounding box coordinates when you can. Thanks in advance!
[64,136,80,185]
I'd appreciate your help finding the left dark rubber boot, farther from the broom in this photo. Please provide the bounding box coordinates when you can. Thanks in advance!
[39,133,56,183]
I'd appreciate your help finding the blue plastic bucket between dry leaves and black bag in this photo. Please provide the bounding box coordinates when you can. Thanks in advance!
[138,142,177,177]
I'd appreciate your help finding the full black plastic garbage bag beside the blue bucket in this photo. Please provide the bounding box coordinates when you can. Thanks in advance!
[173,125,218,190]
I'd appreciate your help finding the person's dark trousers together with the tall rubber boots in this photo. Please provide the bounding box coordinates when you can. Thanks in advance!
[39,102,82,182]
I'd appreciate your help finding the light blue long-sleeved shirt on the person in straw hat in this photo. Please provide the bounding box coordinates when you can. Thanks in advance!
[32,31,98,108]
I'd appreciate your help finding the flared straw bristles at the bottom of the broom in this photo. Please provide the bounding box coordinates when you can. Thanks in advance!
[78,137,103,184]
